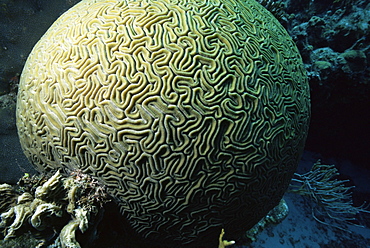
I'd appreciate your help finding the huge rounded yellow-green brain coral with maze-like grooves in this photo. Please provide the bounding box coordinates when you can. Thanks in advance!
[17,0,310,247]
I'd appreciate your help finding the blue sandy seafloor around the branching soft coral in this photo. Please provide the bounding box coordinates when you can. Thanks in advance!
[240,151,370,248]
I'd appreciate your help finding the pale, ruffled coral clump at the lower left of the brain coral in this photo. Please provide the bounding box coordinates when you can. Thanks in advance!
[0,171,109,247]
